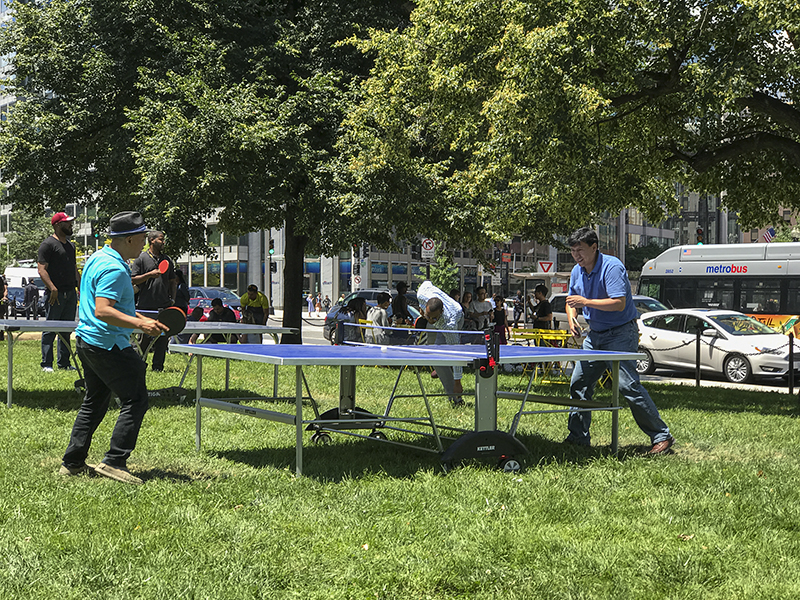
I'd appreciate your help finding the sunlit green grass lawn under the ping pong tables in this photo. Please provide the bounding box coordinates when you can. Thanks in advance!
[0,341,800,600]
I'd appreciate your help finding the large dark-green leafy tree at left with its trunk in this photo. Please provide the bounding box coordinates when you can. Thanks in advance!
[0,0,408,341]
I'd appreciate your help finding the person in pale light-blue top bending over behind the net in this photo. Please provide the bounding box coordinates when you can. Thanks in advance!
[416,281,464,406]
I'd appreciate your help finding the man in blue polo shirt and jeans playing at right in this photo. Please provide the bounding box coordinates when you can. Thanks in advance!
[565,227,675,454]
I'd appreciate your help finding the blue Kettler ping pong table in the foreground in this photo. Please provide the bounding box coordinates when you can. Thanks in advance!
[172,344,642,476]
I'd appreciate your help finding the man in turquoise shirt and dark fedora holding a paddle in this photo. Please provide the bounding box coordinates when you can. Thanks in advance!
[59,212,166,484]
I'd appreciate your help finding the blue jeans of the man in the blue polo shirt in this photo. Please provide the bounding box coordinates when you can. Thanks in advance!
[567,321,670,446]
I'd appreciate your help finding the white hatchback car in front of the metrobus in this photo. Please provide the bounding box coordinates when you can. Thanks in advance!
[636,309,800,383]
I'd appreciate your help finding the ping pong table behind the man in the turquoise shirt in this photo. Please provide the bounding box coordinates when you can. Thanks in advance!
[0,313,297,408]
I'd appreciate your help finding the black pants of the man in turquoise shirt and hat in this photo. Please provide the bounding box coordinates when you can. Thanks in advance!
[63,338,149,467]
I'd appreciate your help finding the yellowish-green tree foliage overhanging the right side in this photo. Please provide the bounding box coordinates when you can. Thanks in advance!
[346,0,800,247]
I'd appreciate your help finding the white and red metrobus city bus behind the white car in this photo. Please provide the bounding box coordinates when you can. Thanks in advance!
[639,242,800,336]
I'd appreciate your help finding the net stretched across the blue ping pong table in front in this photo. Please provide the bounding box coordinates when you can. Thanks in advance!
[334,322,486,346]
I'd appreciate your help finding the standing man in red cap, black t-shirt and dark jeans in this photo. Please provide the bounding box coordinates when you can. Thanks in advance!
[36,212,81,373]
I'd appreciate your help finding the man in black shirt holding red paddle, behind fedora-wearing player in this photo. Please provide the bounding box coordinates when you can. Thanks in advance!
[131,230,177,371]
